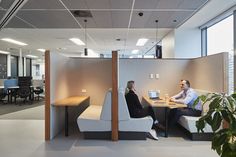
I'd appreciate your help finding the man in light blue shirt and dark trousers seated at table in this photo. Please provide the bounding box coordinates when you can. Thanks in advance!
[169,80,202,126]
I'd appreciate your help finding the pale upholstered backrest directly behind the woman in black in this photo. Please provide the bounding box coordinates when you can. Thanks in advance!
[118,90,130,120]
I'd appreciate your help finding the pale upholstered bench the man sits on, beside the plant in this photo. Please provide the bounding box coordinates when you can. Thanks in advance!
[178,89,212,140]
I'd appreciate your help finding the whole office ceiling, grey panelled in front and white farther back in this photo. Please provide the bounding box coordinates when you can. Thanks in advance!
[0,0,236,57]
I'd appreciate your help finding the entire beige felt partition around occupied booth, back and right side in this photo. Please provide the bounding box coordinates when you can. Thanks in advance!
[119,53,228,98]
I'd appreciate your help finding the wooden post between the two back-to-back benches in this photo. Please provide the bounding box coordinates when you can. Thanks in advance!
[111,51,118,141]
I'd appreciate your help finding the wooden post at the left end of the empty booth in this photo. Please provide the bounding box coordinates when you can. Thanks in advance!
[45,50,50,141]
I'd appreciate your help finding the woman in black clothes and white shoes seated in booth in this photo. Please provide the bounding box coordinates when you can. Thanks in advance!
[125,81,163,140]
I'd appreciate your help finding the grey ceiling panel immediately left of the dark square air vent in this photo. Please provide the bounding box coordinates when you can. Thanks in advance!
[17,10,79,28]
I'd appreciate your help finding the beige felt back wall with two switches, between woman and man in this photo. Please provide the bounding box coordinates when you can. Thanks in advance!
[119,59,191,99]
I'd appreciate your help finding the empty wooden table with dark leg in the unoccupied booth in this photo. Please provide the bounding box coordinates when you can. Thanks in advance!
[53,96,89,136]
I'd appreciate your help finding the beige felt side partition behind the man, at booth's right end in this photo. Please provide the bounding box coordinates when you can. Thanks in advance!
[183,53,228,92]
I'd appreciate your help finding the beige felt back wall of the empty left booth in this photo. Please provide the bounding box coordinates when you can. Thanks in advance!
[67,58,112,105]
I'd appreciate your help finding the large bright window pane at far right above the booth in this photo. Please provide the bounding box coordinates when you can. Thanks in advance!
[207,15,234,55]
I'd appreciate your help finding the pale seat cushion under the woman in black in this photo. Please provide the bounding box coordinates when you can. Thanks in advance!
[119,116,153,132]
